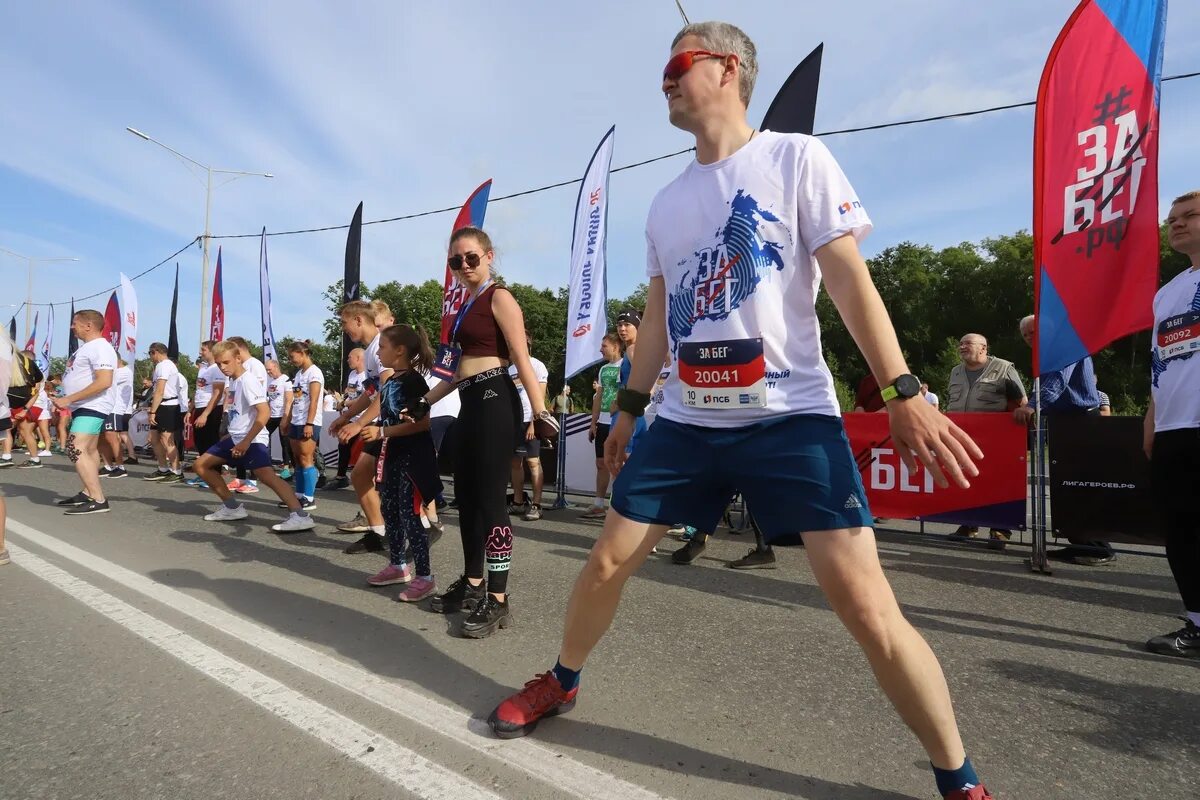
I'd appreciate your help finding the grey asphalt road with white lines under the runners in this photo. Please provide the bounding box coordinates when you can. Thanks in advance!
[0,458,1200,800]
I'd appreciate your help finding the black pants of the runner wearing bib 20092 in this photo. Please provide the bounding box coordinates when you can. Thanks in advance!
[1150,428,1200,613]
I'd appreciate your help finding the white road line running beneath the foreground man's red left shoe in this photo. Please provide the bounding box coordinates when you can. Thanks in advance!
[8,518,667,800]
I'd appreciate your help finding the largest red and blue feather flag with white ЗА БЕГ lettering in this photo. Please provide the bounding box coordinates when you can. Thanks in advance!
[1033,0,1166,374]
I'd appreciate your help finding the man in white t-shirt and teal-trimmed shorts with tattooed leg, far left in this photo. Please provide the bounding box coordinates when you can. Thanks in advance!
[50,308,116,515]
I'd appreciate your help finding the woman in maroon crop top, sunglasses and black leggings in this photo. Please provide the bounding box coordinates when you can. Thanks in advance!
[425,228,552,639]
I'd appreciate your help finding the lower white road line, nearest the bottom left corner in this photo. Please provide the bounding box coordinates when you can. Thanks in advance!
[10,545,500,800]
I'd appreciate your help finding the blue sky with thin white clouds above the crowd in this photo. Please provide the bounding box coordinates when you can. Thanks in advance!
[0,0,1200,354]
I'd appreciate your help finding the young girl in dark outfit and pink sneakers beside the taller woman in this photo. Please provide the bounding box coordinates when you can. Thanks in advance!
[360,325,442,602]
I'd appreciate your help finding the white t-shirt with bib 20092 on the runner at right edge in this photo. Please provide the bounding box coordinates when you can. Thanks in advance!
[1150,269,1200,431]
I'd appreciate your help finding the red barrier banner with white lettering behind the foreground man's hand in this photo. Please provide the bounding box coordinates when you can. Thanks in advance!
[842,413,1027,529]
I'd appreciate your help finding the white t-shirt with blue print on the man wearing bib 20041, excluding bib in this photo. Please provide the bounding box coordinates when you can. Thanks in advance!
[646,131,871,428]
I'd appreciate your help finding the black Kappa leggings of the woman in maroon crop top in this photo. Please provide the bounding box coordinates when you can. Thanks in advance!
[454,367,522,595]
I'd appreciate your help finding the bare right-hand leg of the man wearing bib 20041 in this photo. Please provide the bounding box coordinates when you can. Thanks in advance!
[804,528,966,770]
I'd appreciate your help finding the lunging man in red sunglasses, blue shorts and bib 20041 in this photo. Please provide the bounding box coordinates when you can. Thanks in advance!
[490,23,990,800]
